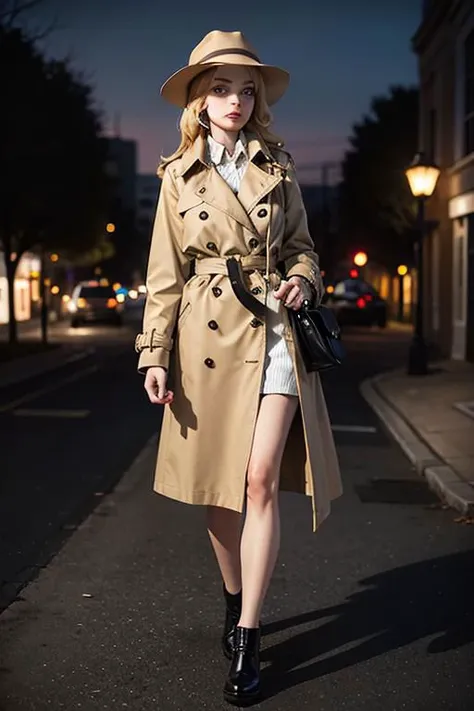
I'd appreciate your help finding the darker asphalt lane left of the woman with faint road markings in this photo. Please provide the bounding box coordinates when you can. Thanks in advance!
[0,319,161,607]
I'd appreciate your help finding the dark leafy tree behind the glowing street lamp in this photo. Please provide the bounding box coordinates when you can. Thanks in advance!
[341,86,418,266]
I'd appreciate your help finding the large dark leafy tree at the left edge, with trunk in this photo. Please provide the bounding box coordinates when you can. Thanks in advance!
[0,26,107,342]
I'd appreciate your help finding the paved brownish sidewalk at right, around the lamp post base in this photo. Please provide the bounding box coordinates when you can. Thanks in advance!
[361,361,474,515]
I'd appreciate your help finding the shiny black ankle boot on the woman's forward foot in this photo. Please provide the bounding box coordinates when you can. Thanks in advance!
[224,627,260,706]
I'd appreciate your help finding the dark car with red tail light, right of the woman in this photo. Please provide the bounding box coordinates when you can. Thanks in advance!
[325,279,387,328]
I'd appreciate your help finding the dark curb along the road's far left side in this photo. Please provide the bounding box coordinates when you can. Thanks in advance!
[0,346,95,390]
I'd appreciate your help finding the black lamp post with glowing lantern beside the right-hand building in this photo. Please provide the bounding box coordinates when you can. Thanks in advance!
[405,153,440,375]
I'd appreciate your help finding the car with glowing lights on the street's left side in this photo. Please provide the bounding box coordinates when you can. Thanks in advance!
[68,281,123,328]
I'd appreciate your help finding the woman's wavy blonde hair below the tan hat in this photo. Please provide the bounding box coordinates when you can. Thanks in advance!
[157,67,283,178]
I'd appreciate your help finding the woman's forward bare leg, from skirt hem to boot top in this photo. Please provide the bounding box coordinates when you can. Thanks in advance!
[239,395,298,628]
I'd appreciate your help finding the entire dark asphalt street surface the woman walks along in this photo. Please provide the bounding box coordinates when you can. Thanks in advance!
[0,329,474,711]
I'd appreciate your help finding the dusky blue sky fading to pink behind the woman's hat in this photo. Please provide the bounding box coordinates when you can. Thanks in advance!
[30,0,421,182]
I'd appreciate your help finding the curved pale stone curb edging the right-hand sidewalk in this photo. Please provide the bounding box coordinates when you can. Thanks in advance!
[359,374,474,516]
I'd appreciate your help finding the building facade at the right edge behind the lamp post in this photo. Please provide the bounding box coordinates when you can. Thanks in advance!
[413,0,474,361]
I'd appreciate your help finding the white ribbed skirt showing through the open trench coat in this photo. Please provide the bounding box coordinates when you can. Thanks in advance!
[260,289,298,395]
